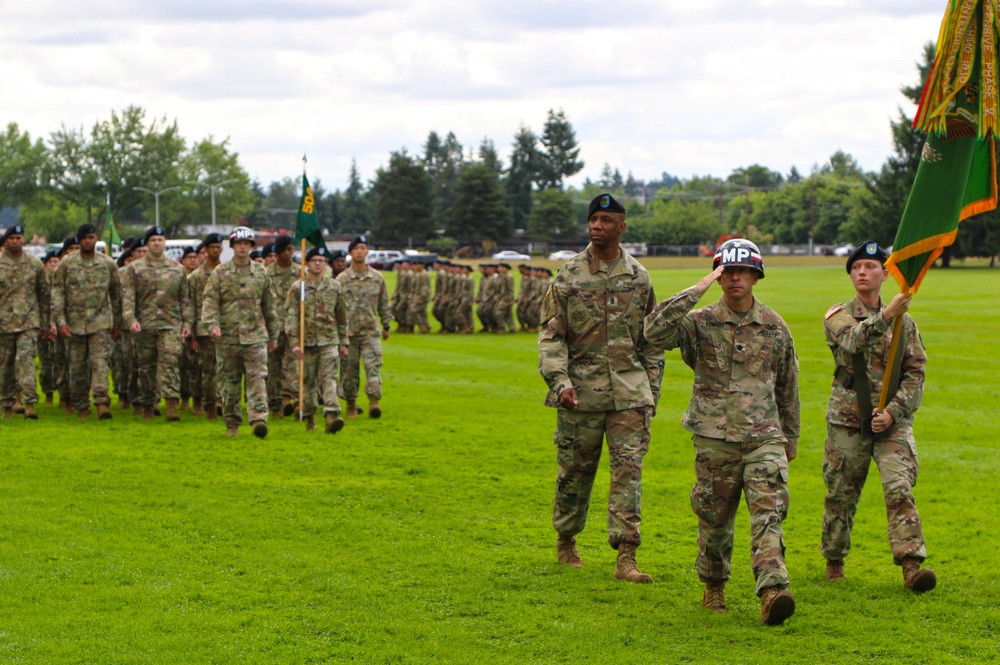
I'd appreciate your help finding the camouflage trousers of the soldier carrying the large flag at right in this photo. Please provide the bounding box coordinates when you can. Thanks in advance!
[820,424,927,566]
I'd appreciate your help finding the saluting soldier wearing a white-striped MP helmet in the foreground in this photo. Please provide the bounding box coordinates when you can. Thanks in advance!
[646,240,799,625]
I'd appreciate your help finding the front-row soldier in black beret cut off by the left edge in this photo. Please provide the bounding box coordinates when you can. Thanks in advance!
[0,224,55,420]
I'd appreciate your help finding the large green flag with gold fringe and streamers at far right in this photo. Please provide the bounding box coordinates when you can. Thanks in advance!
[885,0,1000,293]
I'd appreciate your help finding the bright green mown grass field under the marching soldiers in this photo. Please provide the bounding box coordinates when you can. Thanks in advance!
[0,261,1000,665]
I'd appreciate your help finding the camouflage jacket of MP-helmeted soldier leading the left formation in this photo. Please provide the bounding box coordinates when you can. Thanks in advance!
[201,261,280,345]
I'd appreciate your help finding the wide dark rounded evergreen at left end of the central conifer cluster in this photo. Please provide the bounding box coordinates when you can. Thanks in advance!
[372,148,434,244]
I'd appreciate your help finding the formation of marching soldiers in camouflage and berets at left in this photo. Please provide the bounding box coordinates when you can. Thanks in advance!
[0,224,378,438]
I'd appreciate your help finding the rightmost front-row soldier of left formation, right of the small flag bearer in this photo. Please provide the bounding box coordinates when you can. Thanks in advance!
[337,236,392,418]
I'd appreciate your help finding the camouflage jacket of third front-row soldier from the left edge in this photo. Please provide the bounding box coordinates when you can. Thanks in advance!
[122,254,194,332]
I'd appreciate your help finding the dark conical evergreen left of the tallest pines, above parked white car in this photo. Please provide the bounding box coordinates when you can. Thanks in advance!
[445,162,512,242]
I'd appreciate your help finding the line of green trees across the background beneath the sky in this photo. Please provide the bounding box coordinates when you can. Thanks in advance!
[0,44,1000,256]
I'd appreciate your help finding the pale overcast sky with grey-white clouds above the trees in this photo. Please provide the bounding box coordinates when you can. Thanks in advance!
[0,0,946,189]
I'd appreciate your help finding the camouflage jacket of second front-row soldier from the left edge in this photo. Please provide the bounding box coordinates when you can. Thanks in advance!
[52,252,122,335]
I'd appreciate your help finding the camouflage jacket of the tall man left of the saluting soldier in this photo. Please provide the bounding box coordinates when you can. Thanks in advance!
[538,247,663,411]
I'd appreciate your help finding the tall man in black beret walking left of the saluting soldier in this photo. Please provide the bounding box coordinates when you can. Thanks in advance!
[538,194,663,583]
